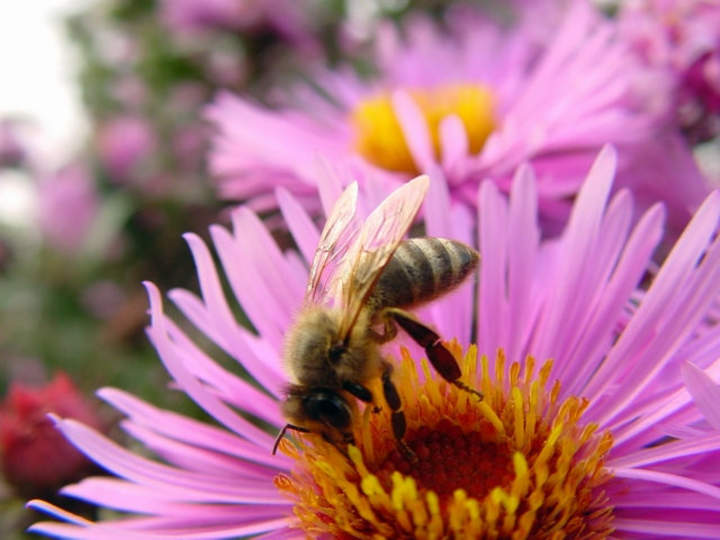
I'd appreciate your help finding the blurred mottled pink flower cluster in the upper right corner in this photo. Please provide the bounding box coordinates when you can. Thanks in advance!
[619,0,720,143]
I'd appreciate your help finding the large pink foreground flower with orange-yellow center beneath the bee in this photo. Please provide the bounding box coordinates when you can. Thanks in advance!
[31,148,720,539]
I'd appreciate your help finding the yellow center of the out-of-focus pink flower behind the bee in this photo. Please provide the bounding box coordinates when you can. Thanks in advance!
[352,84,495,174]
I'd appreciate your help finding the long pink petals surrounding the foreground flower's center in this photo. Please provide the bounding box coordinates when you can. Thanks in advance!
[30,149,720,539]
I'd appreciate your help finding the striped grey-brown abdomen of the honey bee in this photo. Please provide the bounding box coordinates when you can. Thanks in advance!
[368,238,479,310]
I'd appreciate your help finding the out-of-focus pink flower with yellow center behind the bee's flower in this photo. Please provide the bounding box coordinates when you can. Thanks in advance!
[207,2,707,234]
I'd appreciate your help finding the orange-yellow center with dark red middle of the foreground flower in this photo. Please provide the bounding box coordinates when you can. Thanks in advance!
[275,344,613,540]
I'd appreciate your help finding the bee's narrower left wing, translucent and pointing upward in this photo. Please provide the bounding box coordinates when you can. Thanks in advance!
[305,182,358,304]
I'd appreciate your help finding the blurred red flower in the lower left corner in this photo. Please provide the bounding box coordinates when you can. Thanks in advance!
[0,373,102,497]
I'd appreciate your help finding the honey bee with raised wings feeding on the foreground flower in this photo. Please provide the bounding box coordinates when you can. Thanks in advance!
[273,176,482,453]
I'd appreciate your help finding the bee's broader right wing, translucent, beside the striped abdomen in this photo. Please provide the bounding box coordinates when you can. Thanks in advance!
[332,176,430,338]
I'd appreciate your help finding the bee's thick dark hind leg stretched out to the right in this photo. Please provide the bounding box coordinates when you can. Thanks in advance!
[385,308,483,399]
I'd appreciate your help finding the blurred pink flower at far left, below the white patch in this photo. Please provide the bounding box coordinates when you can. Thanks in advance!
[37,164,99,251]
